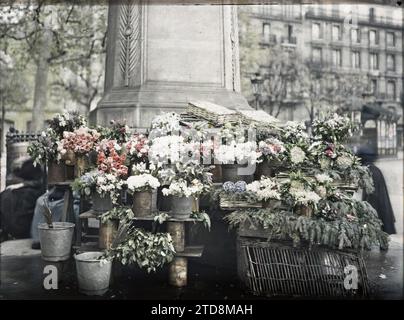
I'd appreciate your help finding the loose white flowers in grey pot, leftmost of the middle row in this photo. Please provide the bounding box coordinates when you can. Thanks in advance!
[72,169,125,213]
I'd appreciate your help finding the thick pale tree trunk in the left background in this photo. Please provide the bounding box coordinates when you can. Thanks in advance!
[31,30,52,132]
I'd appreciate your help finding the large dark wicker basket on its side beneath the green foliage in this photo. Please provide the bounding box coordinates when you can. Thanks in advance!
[237,236,369,298]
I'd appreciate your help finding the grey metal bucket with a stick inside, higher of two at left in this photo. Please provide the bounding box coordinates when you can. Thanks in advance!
[38,222,74,261]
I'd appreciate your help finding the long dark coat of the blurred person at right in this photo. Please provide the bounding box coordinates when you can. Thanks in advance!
[363,163,396,234]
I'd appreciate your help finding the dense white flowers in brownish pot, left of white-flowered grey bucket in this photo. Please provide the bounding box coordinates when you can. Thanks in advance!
[126,172,160,217]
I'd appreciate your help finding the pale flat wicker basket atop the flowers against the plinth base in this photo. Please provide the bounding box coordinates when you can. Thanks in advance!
[187,101,240,125]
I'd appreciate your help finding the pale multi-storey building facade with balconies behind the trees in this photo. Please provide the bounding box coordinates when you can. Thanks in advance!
[239,4,403,155]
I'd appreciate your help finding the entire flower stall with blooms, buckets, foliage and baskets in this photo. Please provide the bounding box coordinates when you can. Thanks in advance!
[29,101,387,296]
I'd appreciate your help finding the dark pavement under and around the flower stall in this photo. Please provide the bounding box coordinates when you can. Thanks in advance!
[0,225,404,300]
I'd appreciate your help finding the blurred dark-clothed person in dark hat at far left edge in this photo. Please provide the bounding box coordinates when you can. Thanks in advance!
[0,157,43,241]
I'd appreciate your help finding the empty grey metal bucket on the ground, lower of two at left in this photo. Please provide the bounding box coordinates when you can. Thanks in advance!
[74,252,112,296]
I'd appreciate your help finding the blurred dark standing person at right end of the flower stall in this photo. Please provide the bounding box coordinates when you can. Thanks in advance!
[357,148,396,234]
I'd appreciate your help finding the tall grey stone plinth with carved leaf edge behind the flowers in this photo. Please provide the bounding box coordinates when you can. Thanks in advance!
[91,0,250,128]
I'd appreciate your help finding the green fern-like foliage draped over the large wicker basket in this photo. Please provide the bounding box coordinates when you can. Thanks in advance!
[225,199,388,250]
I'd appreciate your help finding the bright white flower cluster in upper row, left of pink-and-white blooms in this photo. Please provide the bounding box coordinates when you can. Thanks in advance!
[214,141,261,164]
